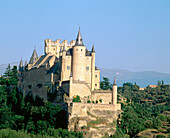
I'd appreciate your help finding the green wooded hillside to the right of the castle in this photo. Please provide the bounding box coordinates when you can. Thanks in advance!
[102,79,170,137]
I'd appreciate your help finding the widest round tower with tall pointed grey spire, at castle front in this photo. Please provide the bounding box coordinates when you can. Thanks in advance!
[72,28,86,81]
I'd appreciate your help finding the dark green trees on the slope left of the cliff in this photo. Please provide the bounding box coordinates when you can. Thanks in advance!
[0,65,83,137]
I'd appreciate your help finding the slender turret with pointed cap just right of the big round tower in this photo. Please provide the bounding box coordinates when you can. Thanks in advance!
[91,45,95,91]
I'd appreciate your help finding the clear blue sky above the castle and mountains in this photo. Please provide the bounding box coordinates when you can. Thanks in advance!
[0,0,170,73]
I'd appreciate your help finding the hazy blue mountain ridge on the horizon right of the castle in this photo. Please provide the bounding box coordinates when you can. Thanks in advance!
[100,68,170,87]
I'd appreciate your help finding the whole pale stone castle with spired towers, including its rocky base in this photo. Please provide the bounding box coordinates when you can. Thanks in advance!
[18,29,121,137]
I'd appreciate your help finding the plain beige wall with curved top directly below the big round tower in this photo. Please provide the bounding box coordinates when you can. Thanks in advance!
[69,81,91,98]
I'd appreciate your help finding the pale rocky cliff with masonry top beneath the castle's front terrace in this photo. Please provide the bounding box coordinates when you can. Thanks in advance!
[68,103,120,137]
